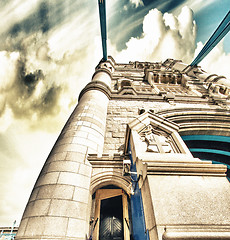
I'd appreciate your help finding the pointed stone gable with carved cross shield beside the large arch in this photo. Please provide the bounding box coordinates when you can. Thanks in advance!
[124,111,193,162]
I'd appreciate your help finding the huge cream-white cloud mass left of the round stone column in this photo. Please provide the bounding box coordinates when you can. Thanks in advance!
[0,0,102,226]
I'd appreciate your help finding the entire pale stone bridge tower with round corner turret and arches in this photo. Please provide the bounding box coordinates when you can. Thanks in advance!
[16,57,230,240]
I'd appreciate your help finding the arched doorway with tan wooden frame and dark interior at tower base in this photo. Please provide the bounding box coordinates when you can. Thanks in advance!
[92,186,130,240]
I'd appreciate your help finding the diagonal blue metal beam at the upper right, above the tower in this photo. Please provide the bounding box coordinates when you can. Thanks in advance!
[190,11,230,66]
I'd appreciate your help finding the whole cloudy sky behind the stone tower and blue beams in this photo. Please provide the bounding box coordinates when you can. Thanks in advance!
[0,0,230,226]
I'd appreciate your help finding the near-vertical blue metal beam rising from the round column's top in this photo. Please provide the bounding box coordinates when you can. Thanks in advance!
[98,0,107,61]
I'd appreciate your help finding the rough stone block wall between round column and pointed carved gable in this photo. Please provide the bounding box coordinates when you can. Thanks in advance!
[103,97,216,154]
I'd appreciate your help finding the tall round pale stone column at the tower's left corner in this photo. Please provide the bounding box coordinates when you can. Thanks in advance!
[16,61,112,240]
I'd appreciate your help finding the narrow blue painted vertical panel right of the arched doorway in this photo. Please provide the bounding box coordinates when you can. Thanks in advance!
[129,143,149,240]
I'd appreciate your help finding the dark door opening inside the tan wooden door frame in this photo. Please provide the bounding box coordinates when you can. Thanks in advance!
[99,196,124,240]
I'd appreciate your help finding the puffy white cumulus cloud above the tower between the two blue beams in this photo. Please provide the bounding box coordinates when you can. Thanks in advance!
[115,7,196,63]
